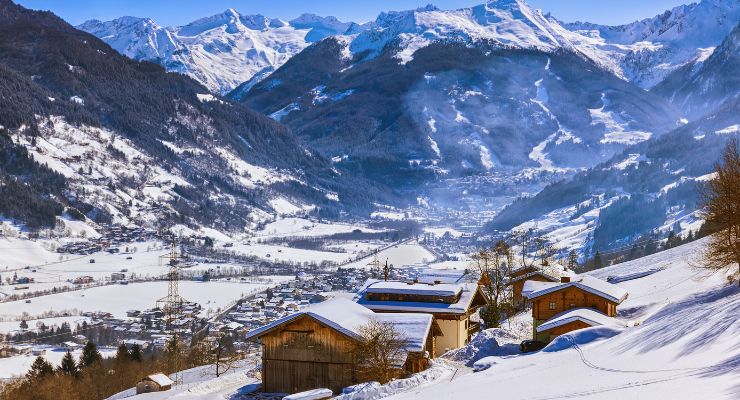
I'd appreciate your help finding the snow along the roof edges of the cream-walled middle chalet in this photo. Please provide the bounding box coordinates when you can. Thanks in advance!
[355,279,486,314]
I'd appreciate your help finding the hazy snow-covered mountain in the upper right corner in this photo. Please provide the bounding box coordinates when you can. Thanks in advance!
[564,0,740,88]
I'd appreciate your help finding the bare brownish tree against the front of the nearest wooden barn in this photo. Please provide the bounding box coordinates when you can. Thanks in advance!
[354,319,408,383]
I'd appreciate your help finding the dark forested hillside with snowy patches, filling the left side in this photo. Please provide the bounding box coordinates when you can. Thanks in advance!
[0,0,369,234]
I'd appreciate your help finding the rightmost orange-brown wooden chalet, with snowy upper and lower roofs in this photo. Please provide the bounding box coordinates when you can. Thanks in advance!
[522,276,627,342]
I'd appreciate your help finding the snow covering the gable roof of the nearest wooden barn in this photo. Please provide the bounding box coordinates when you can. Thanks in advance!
[246,298,433,351]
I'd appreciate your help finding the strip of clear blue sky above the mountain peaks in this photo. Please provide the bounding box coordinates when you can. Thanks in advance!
[16,0,691,25]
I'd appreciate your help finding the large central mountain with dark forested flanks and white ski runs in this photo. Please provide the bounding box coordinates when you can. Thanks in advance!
[238,0,679,206]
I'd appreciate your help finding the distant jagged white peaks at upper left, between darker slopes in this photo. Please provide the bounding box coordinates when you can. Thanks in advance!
[78,9,363,94]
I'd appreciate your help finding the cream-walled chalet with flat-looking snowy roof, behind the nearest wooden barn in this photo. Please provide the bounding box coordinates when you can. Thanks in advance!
[356,279,487,357]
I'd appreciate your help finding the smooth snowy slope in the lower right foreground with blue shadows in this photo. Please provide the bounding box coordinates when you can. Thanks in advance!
[389,241,740,399]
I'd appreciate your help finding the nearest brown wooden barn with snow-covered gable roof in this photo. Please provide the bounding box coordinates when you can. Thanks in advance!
[246,299,441,393]
